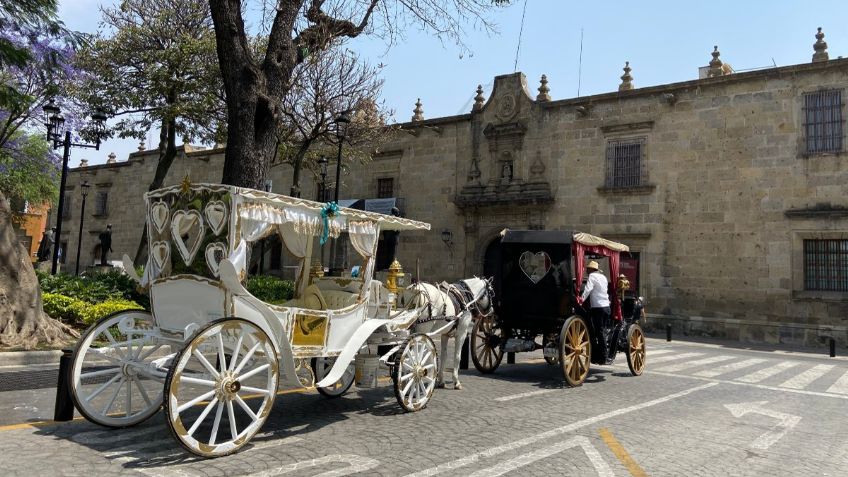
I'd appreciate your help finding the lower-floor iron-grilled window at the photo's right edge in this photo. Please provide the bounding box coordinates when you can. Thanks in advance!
[804,239,848,292]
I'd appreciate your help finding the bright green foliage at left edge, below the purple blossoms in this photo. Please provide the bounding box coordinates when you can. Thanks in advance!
[0,133,59,204]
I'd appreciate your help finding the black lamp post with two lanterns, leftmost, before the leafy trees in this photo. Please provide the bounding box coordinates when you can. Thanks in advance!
[42,99,106,275]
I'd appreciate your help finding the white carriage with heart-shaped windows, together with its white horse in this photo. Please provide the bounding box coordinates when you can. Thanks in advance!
[71,181,491,457]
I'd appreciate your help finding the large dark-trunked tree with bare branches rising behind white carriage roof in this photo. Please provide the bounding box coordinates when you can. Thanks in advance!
[209,0,509,189]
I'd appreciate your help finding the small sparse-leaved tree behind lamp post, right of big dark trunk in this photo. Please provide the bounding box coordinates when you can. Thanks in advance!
[280,47,391,197]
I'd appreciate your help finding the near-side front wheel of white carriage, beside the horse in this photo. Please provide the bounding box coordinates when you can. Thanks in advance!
[392,333,438,412]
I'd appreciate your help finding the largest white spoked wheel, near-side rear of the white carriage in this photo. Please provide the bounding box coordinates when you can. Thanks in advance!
[165,318,279,457]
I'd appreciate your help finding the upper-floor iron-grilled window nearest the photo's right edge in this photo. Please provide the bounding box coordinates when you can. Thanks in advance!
[804,89,842,154]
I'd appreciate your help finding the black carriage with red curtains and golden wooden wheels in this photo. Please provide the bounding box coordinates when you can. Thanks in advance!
[471,230,646,386]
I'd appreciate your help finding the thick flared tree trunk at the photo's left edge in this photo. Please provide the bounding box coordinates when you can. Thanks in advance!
[0,193,79,349]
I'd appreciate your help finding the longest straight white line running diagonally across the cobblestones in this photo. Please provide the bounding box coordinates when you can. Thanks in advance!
[409,383,717,477]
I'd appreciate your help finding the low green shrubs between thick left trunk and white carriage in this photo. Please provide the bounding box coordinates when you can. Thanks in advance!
[37,270,150,310]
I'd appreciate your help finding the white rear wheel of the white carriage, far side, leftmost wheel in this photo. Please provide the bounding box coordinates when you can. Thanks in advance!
[71,310,170,427]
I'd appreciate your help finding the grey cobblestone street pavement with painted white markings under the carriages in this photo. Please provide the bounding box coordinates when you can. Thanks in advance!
[0,340,848,477]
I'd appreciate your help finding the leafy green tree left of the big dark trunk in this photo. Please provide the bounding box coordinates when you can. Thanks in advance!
[77,0,226,263]
